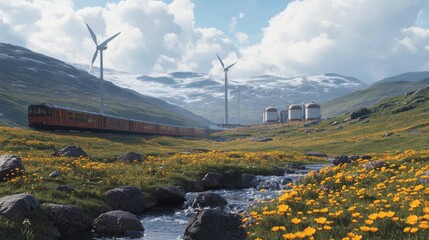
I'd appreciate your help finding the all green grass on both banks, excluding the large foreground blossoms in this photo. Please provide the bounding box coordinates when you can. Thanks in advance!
[0,87,429,239]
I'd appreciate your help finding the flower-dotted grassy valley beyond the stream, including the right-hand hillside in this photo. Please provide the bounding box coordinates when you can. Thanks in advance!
[0,85,429,239]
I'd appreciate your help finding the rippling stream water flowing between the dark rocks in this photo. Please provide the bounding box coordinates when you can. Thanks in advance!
[92,164,327,240]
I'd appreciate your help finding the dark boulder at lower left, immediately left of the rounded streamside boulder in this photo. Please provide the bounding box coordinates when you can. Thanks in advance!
[41,203,90,235]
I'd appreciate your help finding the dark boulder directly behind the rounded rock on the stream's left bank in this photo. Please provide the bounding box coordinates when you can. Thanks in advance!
[105,186,146,213]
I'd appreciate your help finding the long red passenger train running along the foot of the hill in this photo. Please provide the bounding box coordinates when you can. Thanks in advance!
[28,104,207,136]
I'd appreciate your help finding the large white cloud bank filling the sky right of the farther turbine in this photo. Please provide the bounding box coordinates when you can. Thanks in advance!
[226,0,429,81]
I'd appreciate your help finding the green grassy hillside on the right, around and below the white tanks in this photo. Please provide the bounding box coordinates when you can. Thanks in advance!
[207,85,429,155]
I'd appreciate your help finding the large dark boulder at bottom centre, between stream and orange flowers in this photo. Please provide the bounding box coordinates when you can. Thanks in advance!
[183,209,246,240]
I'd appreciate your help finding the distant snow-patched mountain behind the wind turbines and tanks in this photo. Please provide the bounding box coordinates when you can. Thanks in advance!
[77,65,366,123]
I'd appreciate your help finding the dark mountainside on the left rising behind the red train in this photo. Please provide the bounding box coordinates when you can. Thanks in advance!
[0,43,211,126]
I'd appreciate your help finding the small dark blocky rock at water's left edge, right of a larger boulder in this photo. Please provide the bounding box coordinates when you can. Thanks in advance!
[155,187,186,208]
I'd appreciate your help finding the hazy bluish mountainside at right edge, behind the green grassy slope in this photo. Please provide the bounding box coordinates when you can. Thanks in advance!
[322,72,429,117]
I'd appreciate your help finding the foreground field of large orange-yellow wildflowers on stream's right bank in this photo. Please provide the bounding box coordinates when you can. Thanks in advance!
[243,150,429,240]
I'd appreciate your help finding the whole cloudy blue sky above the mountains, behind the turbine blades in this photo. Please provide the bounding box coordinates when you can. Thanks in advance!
[0,0,429,83]
